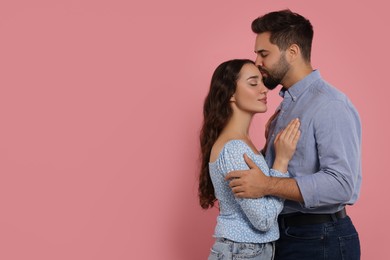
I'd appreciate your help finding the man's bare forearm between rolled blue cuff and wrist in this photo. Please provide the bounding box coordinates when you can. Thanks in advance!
[267,177,303,202]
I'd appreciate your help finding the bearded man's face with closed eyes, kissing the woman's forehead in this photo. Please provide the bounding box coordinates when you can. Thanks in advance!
[255,32,290,90]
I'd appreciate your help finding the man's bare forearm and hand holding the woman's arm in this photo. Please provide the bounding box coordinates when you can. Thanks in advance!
[226,155,303,202]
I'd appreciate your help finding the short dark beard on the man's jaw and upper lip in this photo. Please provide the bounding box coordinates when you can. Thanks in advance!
[259,54,290,90]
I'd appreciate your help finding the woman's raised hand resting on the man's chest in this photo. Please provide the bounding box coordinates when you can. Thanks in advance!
[272,118,301,172]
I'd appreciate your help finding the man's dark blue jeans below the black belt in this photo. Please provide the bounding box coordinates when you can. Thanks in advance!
[275,216,360,260]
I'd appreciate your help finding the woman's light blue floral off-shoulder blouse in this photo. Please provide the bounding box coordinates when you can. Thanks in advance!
[209,140,289,243]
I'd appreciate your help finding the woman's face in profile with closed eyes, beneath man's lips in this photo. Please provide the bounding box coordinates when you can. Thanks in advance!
[230,63,268,114]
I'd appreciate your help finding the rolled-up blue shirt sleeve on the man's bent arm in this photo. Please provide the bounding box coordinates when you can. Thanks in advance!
[295,100,361,208]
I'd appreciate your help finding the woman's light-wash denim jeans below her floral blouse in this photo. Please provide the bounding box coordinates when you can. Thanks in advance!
[208,238,275,260]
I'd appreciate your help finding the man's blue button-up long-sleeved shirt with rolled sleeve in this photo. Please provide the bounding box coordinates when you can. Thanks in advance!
[266,71,362,214]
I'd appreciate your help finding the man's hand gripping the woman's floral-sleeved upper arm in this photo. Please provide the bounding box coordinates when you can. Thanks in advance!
[226,154,270,199]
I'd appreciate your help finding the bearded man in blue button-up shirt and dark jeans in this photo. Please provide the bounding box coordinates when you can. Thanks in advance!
[227,10,361,260]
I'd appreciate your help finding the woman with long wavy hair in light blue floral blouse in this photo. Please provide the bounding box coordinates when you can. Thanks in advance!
[199,60,300,260]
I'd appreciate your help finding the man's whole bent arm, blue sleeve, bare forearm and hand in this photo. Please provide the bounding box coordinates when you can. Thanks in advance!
[227,101,361,208]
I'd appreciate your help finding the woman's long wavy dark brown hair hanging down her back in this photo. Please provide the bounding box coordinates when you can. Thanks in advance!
[198,59,254,209]
